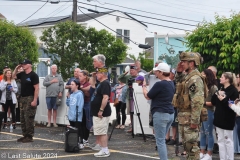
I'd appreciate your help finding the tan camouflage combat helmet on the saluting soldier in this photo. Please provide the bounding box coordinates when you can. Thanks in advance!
[179,52,203,66]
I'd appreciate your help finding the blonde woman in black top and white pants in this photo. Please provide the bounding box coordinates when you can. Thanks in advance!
[211,72,238,160]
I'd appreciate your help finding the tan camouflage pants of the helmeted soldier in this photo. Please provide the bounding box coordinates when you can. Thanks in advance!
[178,124,200,160]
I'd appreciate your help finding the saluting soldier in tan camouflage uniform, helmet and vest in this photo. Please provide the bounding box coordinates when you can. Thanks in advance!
[173,52,205,160]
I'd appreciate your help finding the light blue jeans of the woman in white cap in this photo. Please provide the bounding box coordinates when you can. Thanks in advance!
[153,112,174,160]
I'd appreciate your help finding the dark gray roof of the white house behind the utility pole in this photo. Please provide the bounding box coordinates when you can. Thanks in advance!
[18,11,146,27]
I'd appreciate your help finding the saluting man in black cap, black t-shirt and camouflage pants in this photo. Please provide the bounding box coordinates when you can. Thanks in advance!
[13,59,39,143]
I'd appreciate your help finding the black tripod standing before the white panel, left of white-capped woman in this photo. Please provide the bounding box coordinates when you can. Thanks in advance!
[129,85,146,142]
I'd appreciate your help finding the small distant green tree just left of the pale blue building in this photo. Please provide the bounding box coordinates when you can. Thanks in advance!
[129,52,153,72]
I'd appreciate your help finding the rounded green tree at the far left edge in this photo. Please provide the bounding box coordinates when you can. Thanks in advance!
[0,21,38,71]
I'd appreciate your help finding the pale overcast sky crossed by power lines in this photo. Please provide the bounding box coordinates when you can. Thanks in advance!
[0,0,240,37]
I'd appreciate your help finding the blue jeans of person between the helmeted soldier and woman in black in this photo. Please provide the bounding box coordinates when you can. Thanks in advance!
[200,110,214,151]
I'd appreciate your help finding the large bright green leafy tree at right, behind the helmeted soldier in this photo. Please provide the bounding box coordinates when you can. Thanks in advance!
[186,13,240,75]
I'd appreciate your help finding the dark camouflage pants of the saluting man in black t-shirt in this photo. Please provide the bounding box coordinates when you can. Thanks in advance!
[20,96,37,137]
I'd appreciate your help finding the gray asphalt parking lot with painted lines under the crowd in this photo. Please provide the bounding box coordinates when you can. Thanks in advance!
[0,125,240,160]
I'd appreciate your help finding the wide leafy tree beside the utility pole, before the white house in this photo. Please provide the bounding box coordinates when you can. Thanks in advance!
[40,21,127,79]
